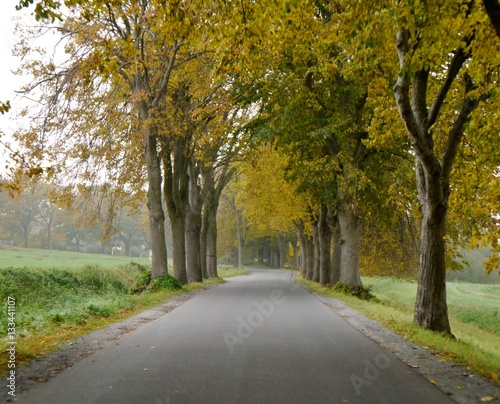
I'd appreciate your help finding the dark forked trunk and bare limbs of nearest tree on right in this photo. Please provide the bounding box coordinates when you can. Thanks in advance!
[394,26,484,335]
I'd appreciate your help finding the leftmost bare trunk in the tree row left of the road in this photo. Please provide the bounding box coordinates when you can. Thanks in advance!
[145,131,168,279]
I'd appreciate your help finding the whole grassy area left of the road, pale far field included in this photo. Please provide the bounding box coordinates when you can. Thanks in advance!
[0,248,248,374]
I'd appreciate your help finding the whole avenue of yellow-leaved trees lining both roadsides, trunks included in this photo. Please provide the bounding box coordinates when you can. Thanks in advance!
[6,0,500,334]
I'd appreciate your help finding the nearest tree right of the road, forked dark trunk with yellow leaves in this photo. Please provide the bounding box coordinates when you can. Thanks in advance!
[351,1,498,334]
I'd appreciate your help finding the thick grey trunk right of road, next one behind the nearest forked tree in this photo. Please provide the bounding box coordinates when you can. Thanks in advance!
[339,202,363,288]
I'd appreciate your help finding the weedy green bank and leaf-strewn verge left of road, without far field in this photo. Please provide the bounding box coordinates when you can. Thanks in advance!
[0,263,248,374]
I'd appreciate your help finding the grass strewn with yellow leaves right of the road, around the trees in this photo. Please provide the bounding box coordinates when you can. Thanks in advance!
[296,277,500,384]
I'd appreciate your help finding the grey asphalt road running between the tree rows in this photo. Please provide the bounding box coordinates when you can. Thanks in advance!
[18,270,453,404]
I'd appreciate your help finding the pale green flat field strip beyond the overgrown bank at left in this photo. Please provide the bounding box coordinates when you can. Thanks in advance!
[0,246,150,268]
